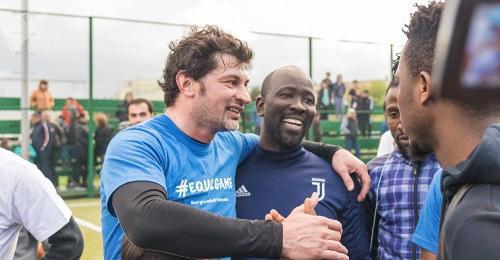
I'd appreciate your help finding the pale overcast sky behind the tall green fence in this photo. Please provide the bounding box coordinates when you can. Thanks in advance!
[0,0,427,98]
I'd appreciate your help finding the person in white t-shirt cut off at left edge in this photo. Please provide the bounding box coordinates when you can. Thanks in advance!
[0,148,83,260]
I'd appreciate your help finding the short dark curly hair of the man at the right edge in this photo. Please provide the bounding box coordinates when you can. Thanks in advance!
[403,1,444,77]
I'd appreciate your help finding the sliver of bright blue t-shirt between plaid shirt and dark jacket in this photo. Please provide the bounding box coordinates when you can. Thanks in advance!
[411,170,442,254]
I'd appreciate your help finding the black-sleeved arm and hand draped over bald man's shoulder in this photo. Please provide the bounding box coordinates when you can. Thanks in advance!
[303,141,371,201]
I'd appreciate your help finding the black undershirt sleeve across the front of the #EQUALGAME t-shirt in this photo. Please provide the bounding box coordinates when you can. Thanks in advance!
[111,181,283,258]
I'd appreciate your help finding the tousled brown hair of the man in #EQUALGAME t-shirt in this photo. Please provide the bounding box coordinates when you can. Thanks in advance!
[158,25,253,107]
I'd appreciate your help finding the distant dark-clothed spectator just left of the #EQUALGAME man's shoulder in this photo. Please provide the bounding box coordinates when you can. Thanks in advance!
[94,113,113,163]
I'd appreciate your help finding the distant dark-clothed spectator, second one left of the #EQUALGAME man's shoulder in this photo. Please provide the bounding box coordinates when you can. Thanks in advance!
[68,114,88,188]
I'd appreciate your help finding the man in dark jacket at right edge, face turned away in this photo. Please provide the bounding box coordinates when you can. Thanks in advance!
[395,2,500,260]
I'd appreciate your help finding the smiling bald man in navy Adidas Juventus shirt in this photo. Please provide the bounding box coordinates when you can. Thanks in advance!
[236,66,370,259]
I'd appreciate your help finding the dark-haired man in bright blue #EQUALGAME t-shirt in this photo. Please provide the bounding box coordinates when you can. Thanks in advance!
[101,26,369,259]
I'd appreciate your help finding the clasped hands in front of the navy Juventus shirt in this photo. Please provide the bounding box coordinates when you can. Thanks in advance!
[265,192,349,259]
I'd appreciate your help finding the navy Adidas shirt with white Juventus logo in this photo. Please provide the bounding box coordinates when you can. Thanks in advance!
[236,147,370,259]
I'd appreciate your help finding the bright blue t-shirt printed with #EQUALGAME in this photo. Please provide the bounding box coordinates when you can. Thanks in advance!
[101,114,258,259]
